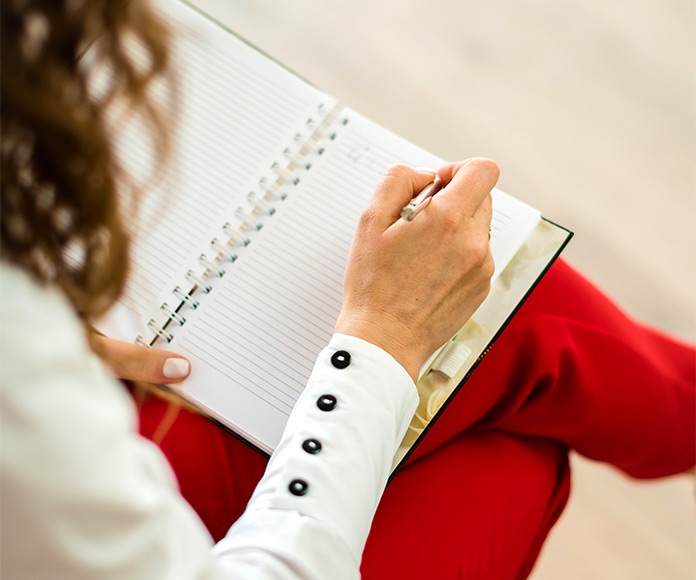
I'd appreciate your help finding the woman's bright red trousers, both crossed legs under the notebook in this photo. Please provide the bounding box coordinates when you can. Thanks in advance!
[141,261,696,580]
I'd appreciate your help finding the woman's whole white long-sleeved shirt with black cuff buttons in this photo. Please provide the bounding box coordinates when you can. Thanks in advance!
[0,266,417,580]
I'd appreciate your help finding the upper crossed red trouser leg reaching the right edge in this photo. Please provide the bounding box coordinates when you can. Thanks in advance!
[414,261,696,477]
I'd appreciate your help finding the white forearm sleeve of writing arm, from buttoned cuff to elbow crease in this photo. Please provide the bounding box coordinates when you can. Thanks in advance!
[215,335,418,579]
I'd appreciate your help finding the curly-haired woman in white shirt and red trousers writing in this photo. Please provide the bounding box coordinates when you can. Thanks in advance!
[0,0,694,579]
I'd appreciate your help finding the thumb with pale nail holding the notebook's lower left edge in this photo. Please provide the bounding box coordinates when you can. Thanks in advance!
[94,336,191,383]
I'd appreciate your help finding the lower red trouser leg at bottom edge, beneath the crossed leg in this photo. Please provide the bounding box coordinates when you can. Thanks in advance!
[361,430,570,580]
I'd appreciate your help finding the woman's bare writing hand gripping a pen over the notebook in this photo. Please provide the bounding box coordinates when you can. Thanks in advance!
[335,159,499,381]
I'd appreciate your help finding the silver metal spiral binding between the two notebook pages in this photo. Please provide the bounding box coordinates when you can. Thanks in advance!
[135,104,348,347]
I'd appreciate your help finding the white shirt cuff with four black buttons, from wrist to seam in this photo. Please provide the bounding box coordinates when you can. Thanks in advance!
[223,334,418,565]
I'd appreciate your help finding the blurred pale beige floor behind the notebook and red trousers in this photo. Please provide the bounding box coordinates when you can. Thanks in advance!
[194,0,696,580]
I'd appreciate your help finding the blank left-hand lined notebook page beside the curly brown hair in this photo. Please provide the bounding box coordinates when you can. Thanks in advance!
[95,0,335,340]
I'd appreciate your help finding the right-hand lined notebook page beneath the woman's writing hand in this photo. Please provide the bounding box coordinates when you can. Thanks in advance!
[171,111,538,451]
